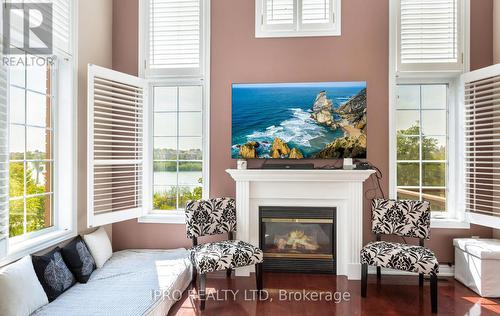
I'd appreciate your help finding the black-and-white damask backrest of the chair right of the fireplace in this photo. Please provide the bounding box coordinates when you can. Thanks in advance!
[372,199,431,239]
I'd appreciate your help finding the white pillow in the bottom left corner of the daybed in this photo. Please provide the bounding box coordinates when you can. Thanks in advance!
[0,256,49,316]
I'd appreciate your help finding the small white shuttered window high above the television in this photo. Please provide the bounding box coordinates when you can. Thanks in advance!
[255,0,341,37]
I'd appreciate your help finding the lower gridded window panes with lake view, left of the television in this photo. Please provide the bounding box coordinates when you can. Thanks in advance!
[153,86,203,210]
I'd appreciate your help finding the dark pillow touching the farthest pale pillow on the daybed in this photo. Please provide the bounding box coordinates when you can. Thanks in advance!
[61,236,96,283]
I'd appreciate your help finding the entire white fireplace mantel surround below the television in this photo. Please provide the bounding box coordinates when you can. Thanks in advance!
[226,169,375,280]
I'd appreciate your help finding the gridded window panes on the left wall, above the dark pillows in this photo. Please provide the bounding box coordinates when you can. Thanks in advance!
[9,56,54,237]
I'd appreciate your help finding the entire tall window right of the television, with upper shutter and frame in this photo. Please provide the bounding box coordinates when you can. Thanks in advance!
[389,0,470,228]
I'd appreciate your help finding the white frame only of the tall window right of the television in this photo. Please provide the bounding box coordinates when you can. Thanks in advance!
[388,0,470,229]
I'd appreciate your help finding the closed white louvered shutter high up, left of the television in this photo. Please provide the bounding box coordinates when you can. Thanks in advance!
[148,0,202,74]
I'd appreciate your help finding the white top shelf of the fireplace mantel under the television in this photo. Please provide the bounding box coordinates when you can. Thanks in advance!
[226,169,375,182]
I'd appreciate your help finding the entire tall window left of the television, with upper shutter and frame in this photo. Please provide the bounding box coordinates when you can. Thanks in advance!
[139,0,210,223]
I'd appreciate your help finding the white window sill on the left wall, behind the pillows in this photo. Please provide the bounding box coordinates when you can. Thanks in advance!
[0,230,77,267]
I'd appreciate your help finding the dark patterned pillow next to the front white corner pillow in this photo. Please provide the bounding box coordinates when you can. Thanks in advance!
[32,247,76,302]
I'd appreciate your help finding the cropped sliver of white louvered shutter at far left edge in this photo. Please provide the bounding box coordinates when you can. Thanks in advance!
[0,24,9,258]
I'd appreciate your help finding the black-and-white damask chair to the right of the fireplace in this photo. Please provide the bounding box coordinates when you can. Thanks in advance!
[361,199,439,313]
